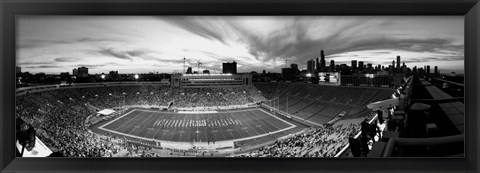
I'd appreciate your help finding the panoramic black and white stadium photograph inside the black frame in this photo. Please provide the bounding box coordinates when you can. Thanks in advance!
[12,15,465,158]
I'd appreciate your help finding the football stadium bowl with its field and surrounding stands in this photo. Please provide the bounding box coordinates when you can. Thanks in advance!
[17,71,394,157]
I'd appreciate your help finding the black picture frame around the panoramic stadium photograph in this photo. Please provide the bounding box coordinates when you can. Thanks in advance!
[0,0,480,172]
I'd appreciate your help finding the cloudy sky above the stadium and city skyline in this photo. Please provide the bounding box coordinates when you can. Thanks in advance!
[16,16,464,74]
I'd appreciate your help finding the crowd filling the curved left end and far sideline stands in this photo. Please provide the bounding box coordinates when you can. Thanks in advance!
[16,85,258,157]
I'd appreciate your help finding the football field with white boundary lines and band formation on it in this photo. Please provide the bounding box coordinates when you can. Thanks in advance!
[99,109,295,142]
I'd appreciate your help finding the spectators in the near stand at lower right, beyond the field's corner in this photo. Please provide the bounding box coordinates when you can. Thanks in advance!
[237,123,360,157]
